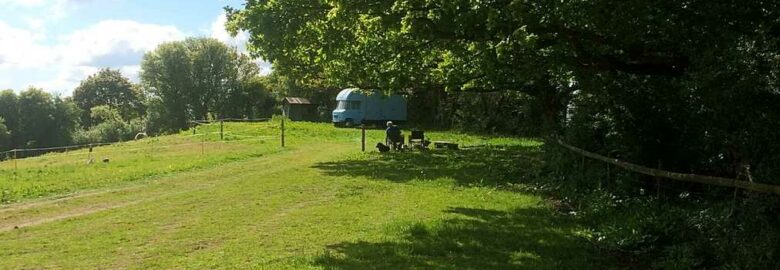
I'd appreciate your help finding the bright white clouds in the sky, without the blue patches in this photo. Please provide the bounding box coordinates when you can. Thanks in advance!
[0,11,271,95]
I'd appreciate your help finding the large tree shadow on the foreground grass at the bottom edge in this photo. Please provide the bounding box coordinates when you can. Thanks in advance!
[315,208,604,269]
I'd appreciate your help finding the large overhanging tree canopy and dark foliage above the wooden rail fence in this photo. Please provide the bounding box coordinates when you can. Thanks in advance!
[228,0,780,179]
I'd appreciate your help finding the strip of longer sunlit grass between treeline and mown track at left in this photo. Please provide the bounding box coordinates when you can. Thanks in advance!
[0,119,281,203]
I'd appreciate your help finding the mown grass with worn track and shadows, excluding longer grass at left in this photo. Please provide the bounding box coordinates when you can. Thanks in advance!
[0,123,609,269]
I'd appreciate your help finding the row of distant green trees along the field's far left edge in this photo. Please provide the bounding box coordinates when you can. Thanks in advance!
[0,38,277,151]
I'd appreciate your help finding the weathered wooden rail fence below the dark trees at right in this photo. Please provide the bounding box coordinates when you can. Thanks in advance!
[557,140,780,195]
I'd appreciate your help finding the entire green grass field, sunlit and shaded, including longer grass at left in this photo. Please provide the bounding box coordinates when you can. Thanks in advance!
[0,121,612,269]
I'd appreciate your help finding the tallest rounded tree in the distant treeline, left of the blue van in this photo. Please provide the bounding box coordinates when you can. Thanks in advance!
[141,38,273,131]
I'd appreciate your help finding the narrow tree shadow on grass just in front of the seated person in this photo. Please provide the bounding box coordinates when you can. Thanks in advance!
[314,145,542,186]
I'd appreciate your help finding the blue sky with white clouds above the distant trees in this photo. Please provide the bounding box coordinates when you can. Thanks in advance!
[0,0,270,96]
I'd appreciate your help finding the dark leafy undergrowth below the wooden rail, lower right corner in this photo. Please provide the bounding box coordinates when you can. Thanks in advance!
[568,191,780,269]
